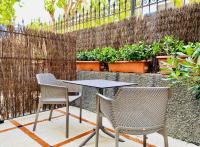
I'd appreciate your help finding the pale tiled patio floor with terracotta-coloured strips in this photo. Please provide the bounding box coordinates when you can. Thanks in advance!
[0,107,196,147]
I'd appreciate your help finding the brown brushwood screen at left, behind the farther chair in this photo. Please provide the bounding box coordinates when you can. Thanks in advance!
[0,29,76,119]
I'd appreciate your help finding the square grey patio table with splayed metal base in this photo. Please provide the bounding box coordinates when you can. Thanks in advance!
[63,79,137,147]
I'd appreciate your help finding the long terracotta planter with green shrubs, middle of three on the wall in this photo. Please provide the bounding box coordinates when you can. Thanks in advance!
[102,42,150,73]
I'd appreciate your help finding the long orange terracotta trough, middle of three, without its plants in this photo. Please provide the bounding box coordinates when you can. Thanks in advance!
[108,60,149,73]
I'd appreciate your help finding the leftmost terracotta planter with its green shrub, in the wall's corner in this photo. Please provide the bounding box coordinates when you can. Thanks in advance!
[76,48,101,71]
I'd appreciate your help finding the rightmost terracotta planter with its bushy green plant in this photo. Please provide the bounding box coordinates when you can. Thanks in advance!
[155,36,191,74]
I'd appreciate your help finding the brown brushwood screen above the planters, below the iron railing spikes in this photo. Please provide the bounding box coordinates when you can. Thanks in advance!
[71,4,200,50]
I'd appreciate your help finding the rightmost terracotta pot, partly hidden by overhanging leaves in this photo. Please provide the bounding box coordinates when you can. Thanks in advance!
[156,56,188,75]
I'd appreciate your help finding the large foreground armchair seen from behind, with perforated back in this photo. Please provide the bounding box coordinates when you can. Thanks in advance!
[96,87,170,147]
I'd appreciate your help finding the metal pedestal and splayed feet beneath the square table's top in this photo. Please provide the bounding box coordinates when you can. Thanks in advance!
[79,89,125,147]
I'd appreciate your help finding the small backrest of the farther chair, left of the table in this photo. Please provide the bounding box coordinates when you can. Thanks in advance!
[36,73,57,85]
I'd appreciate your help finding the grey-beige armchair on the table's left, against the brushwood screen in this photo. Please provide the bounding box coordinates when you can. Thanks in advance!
[33,73,82,137]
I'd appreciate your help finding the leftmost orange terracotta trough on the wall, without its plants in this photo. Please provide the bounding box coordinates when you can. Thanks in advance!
[76,61,101,71]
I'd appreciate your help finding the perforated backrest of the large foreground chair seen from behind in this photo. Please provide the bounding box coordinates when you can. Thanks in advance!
[112,87,169,128]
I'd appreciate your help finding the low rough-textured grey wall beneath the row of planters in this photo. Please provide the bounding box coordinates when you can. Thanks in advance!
[74,71,200,145]
